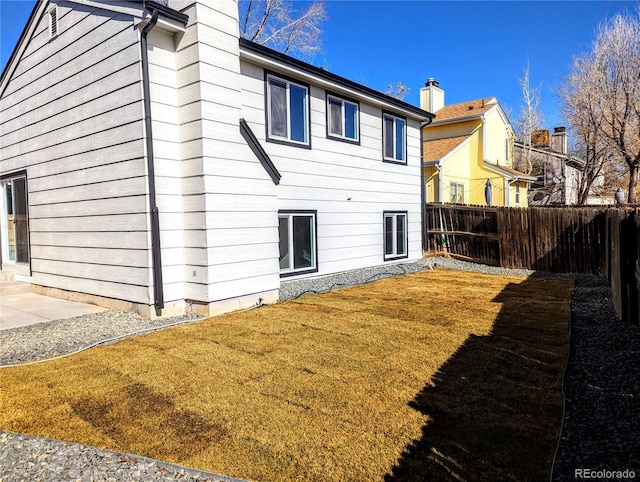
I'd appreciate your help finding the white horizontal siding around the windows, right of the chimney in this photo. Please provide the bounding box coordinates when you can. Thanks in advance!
[241,62,422,276]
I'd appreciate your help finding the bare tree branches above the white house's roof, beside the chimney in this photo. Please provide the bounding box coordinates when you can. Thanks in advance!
[239,0,327,58]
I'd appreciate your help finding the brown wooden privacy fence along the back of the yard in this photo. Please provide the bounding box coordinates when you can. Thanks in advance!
[425,204,640,322]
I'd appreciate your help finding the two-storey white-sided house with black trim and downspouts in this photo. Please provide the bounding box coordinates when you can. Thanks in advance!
[0,0,433,316]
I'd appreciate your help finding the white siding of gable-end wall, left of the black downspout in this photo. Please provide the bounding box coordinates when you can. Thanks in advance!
[0,3,150,304]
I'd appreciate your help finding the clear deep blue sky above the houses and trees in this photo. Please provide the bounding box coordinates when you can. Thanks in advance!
[0,0,640,128]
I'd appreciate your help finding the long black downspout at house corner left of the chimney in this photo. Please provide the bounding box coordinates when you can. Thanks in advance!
[140,10,164,316]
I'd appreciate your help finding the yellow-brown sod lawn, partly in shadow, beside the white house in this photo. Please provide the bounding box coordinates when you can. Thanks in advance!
[0,269,573,481]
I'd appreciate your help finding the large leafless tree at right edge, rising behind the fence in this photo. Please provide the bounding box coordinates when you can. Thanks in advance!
[560,9,640,204]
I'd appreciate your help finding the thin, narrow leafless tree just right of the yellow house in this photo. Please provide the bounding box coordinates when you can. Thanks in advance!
[514,61,544,174]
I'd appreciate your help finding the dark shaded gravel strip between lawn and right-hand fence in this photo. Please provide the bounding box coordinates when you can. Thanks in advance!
[552,277,640,482]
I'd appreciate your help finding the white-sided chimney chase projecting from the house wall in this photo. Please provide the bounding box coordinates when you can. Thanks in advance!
[177,2,279,302]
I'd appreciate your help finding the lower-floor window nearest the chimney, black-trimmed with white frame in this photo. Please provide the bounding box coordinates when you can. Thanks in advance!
[278,211,318,276]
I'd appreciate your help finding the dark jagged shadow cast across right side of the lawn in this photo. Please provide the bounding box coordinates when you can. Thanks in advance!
[385,277,568,481]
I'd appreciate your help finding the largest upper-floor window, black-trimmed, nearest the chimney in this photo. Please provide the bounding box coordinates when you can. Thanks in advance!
[267,75,309,146]
